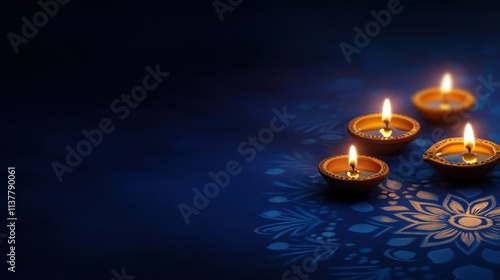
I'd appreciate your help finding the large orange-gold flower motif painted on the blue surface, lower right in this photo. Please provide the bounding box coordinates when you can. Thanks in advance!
[395,195,500,255]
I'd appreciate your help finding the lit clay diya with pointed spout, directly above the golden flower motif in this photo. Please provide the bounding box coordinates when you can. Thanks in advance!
[423,124,500,178]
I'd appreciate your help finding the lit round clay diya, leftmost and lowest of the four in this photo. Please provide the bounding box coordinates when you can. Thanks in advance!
[318,146,389,192]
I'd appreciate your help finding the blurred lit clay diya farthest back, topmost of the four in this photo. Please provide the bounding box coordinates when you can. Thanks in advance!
[412,73,476,123]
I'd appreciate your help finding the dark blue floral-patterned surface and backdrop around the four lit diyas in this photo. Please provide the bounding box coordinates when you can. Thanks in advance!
[0,0,500,280]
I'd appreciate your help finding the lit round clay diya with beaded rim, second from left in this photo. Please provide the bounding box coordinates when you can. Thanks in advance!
[347,99,420,154]
